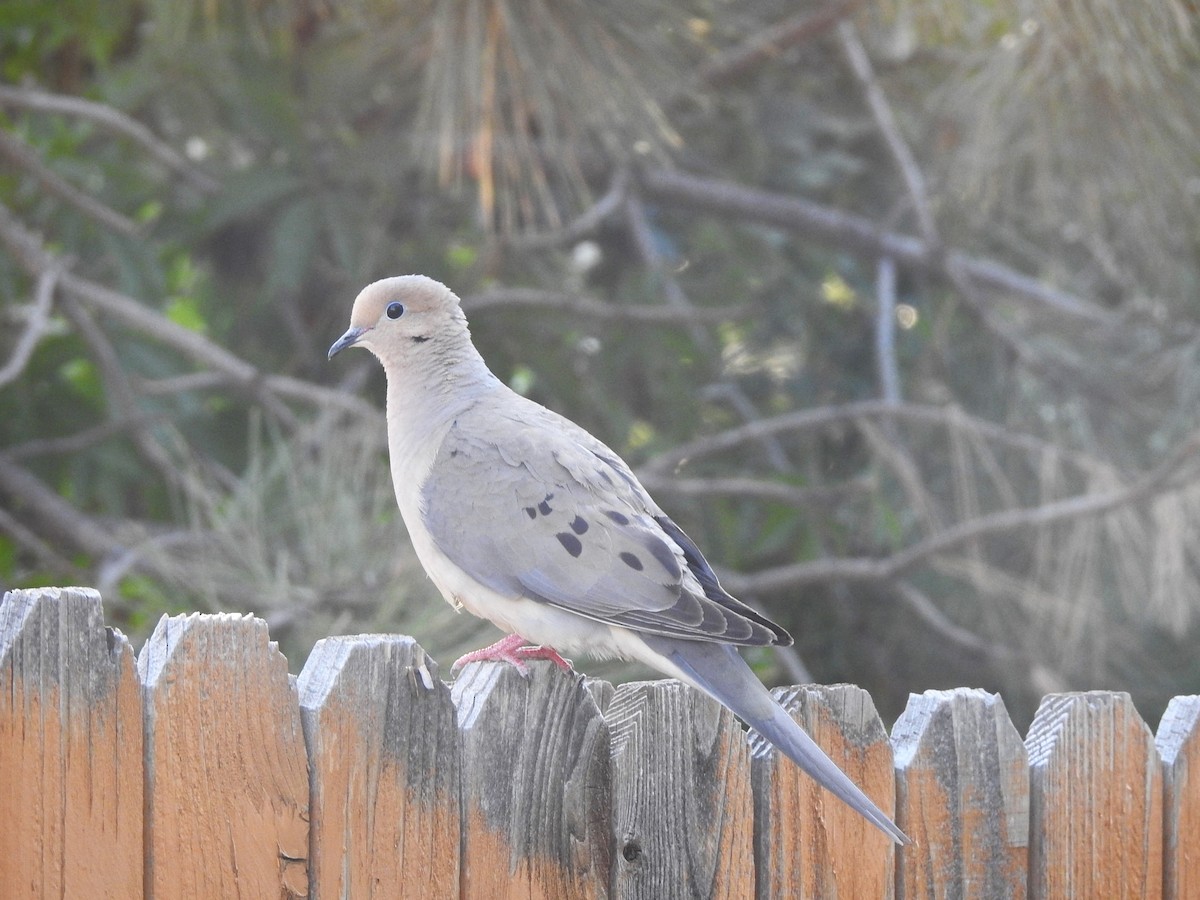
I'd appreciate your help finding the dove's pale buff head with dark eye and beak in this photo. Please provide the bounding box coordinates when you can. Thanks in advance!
[329,275,469,362]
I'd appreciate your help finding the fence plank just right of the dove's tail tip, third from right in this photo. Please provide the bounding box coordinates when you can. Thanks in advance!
[892,688,1030,900]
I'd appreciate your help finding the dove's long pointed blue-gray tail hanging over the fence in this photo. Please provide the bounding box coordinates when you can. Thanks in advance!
[642,635,910,844]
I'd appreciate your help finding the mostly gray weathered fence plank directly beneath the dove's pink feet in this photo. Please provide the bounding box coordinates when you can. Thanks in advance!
[451,662,612,900]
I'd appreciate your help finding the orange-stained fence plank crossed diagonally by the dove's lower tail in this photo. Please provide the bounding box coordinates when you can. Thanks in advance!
[751,684,895,898]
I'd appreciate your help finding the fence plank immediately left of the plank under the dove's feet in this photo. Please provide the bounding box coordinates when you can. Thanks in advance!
[298,635,462,900]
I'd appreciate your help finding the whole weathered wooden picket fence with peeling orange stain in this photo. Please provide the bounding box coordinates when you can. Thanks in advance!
[0,588,1200,900]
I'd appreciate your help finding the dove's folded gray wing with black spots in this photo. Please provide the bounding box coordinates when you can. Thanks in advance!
[421,402,791,644]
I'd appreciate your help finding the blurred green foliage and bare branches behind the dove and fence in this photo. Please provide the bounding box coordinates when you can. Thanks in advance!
[0,0,1200,721]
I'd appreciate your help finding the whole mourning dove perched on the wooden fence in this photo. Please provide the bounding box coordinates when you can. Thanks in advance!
[329,275,907,844]
